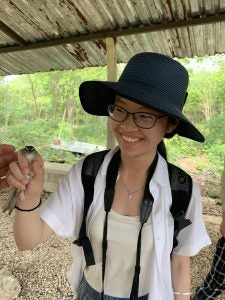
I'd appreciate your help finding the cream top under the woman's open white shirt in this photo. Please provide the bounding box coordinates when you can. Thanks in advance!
[84,206,154,298]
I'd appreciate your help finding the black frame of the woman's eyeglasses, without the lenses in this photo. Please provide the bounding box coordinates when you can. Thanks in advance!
[107,104,167,129]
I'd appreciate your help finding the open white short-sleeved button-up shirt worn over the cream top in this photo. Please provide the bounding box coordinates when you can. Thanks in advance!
[40,148,210,300]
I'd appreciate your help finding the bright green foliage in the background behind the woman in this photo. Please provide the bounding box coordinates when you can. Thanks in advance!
[0,56,225,171]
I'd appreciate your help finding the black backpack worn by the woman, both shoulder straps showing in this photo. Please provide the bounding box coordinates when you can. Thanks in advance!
[73,150,192,266]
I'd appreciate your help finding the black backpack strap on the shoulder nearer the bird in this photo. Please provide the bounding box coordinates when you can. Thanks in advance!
[73,150,109,266]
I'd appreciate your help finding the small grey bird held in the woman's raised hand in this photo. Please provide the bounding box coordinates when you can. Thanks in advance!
[2,146,39,215]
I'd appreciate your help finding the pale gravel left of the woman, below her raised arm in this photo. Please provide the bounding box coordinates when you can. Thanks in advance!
[0,190,74,300]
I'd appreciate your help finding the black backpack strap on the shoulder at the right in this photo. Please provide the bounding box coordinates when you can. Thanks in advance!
[167,162,193,248]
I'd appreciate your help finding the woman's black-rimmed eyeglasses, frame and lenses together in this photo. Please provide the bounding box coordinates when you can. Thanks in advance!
[108,105,166,129]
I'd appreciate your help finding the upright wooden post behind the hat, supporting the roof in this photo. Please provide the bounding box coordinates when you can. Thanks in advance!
[105,37,117,149]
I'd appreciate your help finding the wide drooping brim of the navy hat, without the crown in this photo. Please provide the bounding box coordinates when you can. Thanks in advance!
[79,81,205,142]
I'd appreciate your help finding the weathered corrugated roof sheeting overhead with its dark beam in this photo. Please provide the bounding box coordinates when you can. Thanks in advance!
[0,0,225,75]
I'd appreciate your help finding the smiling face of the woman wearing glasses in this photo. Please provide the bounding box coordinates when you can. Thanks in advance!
[110,96,177,161]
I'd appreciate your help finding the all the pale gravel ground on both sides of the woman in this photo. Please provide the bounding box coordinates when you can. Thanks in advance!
[0,182,225,300]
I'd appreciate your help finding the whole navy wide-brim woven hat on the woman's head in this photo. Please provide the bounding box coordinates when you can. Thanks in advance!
[79,52,204,142]
